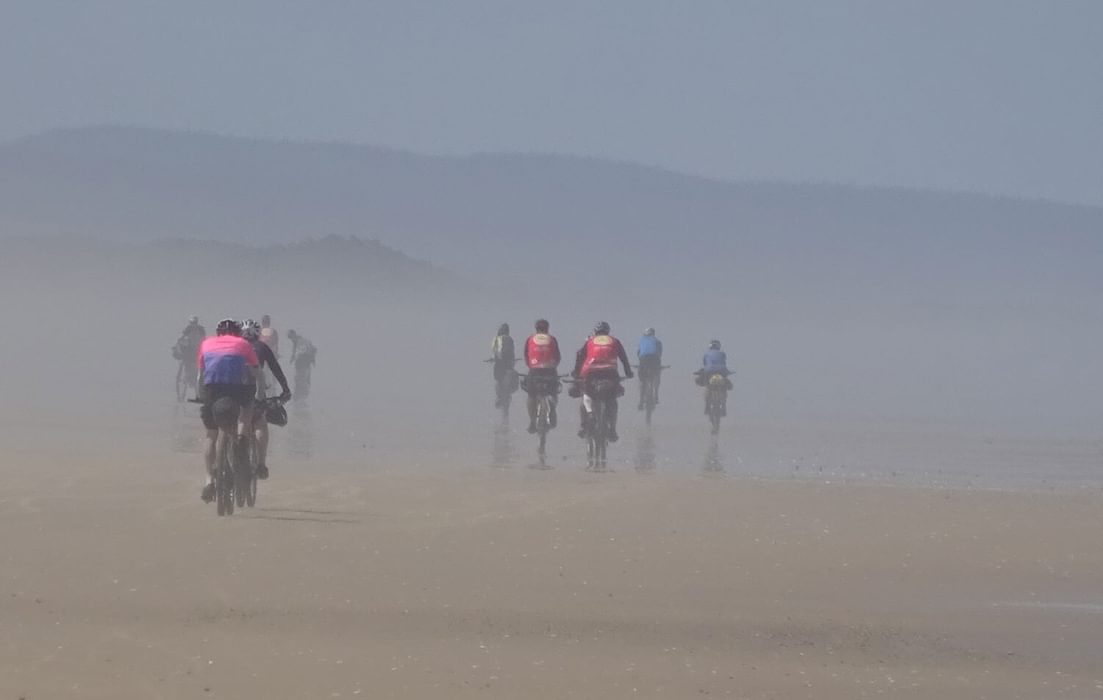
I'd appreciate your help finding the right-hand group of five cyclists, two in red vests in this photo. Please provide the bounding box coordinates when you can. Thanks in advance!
[491,319,731,442]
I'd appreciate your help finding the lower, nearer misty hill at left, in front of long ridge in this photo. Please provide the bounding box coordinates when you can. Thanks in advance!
[0,236,467,301]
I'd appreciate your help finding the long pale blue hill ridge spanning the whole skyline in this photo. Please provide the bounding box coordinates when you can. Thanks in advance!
[0,128,1103,303]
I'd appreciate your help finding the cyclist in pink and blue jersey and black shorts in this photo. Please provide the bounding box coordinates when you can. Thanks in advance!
[196,319,258,503]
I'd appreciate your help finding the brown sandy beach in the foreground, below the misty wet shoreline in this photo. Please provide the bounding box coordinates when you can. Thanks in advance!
[0,432,1103,700]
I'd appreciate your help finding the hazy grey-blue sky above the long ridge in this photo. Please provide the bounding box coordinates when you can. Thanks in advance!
[0,0,1103,205]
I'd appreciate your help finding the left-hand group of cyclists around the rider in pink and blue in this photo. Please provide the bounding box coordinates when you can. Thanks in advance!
[173,315,315,503]
